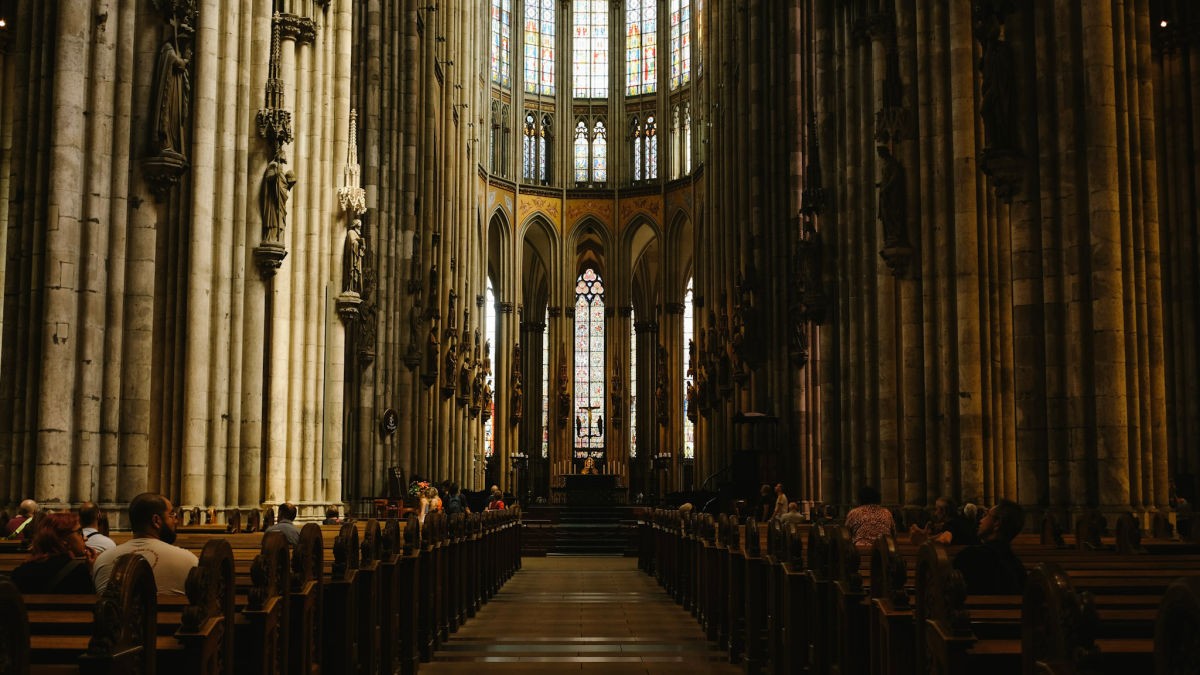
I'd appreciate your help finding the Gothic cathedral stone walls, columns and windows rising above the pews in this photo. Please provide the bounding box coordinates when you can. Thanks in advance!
[0,0,1200,522]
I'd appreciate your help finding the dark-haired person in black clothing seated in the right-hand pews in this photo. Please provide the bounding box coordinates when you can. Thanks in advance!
[954,500,1026,596]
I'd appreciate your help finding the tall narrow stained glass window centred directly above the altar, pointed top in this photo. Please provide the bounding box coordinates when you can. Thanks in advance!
[575,268,605,456]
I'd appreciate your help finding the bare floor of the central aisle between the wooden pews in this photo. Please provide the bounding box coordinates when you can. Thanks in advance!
[420,557,742,675]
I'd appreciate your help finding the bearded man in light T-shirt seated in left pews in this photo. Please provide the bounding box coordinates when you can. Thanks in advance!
[92,492,200,596]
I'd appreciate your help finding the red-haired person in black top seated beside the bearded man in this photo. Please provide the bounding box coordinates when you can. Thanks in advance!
[12,510,95,593]
